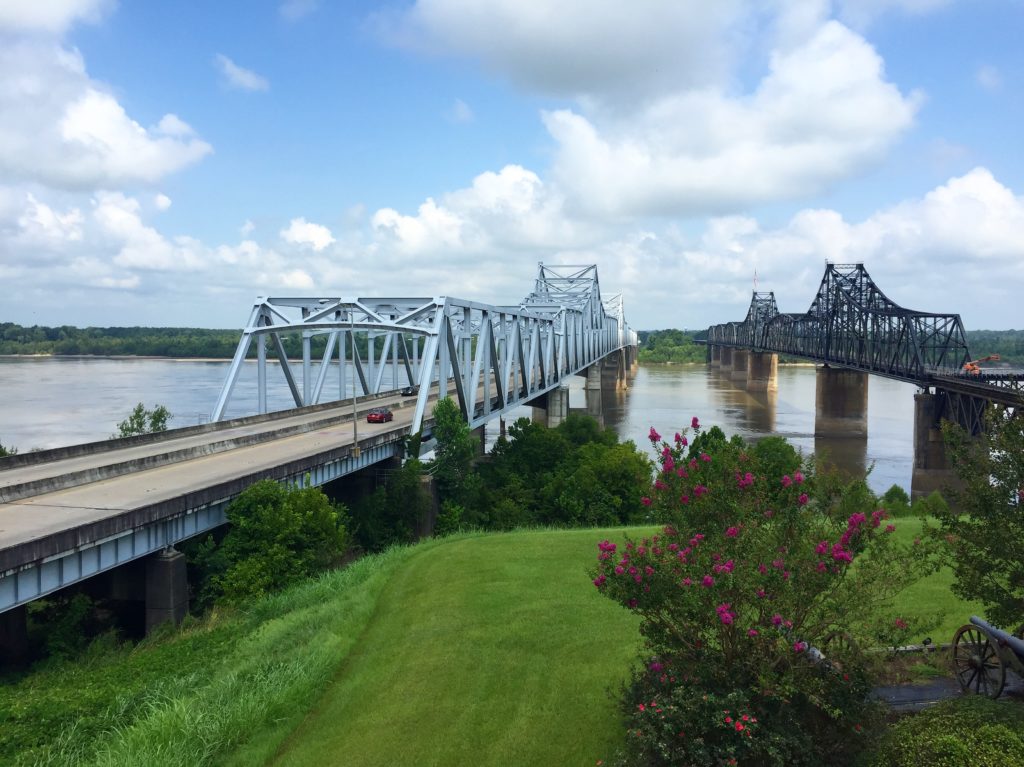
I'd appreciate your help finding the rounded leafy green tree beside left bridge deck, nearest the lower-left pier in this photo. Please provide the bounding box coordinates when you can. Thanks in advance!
[198,479,347,603]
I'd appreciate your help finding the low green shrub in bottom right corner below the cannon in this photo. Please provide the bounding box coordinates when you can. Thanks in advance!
[861,695,1024,767]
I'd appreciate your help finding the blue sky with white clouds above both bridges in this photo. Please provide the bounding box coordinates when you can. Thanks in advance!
[0,0,1024,328]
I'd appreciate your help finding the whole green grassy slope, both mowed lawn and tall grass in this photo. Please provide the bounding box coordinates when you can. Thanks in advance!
[0,518,979,767]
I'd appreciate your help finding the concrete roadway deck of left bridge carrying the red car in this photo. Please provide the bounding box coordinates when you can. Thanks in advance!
[0,395,436,573]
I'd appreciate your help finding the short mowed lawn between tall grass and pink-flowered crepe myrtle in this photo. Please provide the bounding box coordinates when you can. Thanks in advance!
[268,530,639,766]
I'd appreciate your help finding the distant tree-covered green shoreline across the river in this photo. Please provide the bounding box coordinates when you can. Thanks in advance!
[0,323,1024,365]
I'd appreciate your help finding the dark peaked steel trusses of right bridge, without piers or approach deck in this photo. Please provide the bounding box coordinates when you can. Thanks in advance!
[708,264,971,384]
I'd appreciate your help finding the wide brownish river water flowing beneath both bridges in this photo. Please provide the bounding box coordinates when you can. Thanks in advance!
[0,356,915,493]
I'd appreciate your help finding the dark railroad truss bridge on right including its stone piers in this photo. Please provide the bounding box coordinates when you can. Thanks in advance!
[707,263,1022,498]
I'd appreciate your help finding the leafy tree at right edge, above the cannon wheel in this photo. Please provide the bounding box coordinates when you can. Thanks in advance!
[929,408,1024,629]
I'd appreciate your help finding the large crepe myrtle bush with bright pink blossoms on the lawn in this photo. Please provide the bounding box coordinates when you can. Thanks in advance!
[591,418,934,765]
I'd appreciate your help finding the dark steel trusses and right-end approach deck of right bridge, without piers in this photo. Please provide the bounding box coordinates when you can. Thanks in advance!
[708,263,1022,432]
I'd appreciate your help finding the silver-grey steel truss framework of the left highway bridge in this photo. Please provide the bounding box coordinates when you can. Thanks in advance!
[212,263,637,433]
